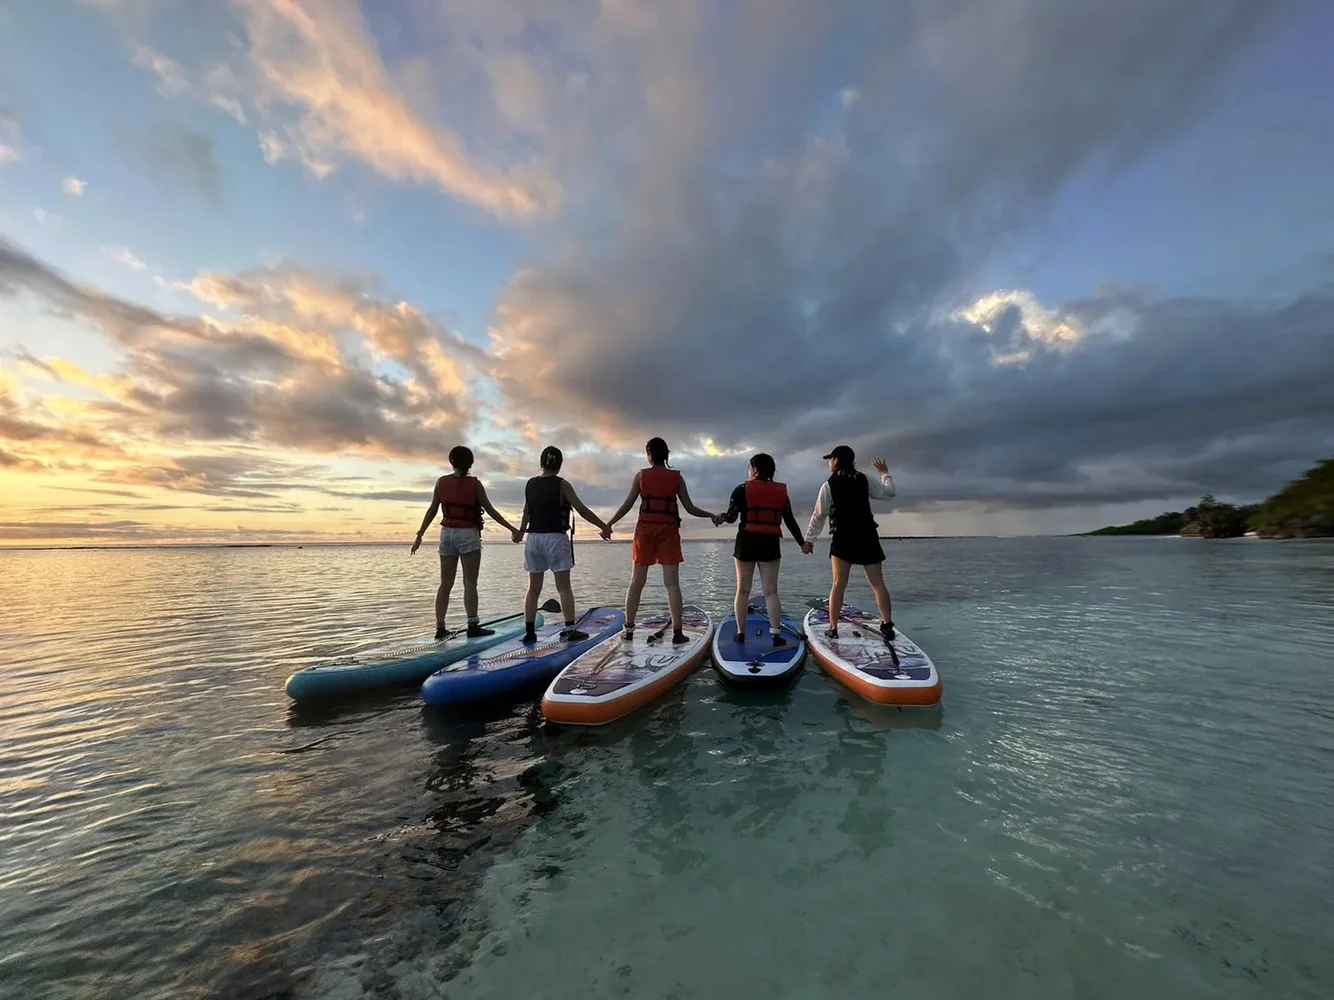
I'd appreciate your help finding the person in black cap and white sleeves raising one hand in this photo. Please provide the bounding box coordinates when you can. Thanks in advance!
[806,444,894,643]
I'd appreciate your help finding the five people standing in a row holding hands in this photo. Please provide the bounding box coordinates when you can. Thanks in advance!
[412,437,895,645]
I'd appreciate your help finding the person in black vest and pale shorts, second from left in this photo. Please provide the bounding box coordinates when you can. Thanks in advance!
[514,445,611,643]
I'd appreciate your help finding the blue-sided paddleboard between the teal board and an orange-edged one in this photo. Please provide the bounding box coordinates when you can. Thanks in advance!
[422,608,626,705]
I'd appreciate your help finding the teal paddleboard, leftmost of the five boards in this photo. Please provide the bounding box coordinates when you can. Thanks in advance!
[284,612,543,701]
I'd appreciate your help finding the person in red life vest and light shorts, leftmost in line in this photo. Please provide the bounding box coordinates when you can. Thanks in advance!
[412,444,515,639]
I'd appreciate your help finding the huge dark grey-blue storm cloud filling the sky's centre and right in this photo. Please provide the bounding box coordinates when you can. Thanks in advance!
[495,0,1312,507]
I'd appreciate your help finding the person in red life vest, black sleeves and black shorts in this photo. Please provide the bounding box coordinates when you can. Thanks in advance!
[714,452,810,645]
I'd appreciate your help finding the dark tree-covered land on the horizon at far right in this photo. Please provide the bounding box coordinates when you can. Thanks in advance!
[1085,459,1334,539]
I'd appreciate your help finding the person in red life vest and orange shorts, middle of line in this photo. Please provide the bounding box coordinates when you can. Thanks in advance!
[607,437,714,643]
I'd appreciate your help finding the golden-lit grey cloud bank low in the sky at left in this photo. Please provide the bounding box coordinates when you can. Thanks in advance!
[0,241,482,474]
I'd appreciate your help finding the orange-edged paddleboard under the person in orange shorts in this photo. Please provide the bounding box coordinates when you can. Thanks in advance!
[542,607,714,725]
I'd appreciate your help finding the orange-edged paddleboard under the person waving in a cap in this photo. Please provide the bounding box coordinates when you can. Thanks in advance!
[806,604,942,705]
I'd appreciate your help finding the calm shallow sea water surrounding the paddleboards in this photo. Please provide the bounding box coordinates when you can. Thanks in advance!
[0,539,1334,997]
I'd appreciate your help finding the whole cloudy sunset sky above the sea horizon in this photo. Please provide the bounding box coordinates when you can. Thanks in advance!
[0,0,1334,545]
